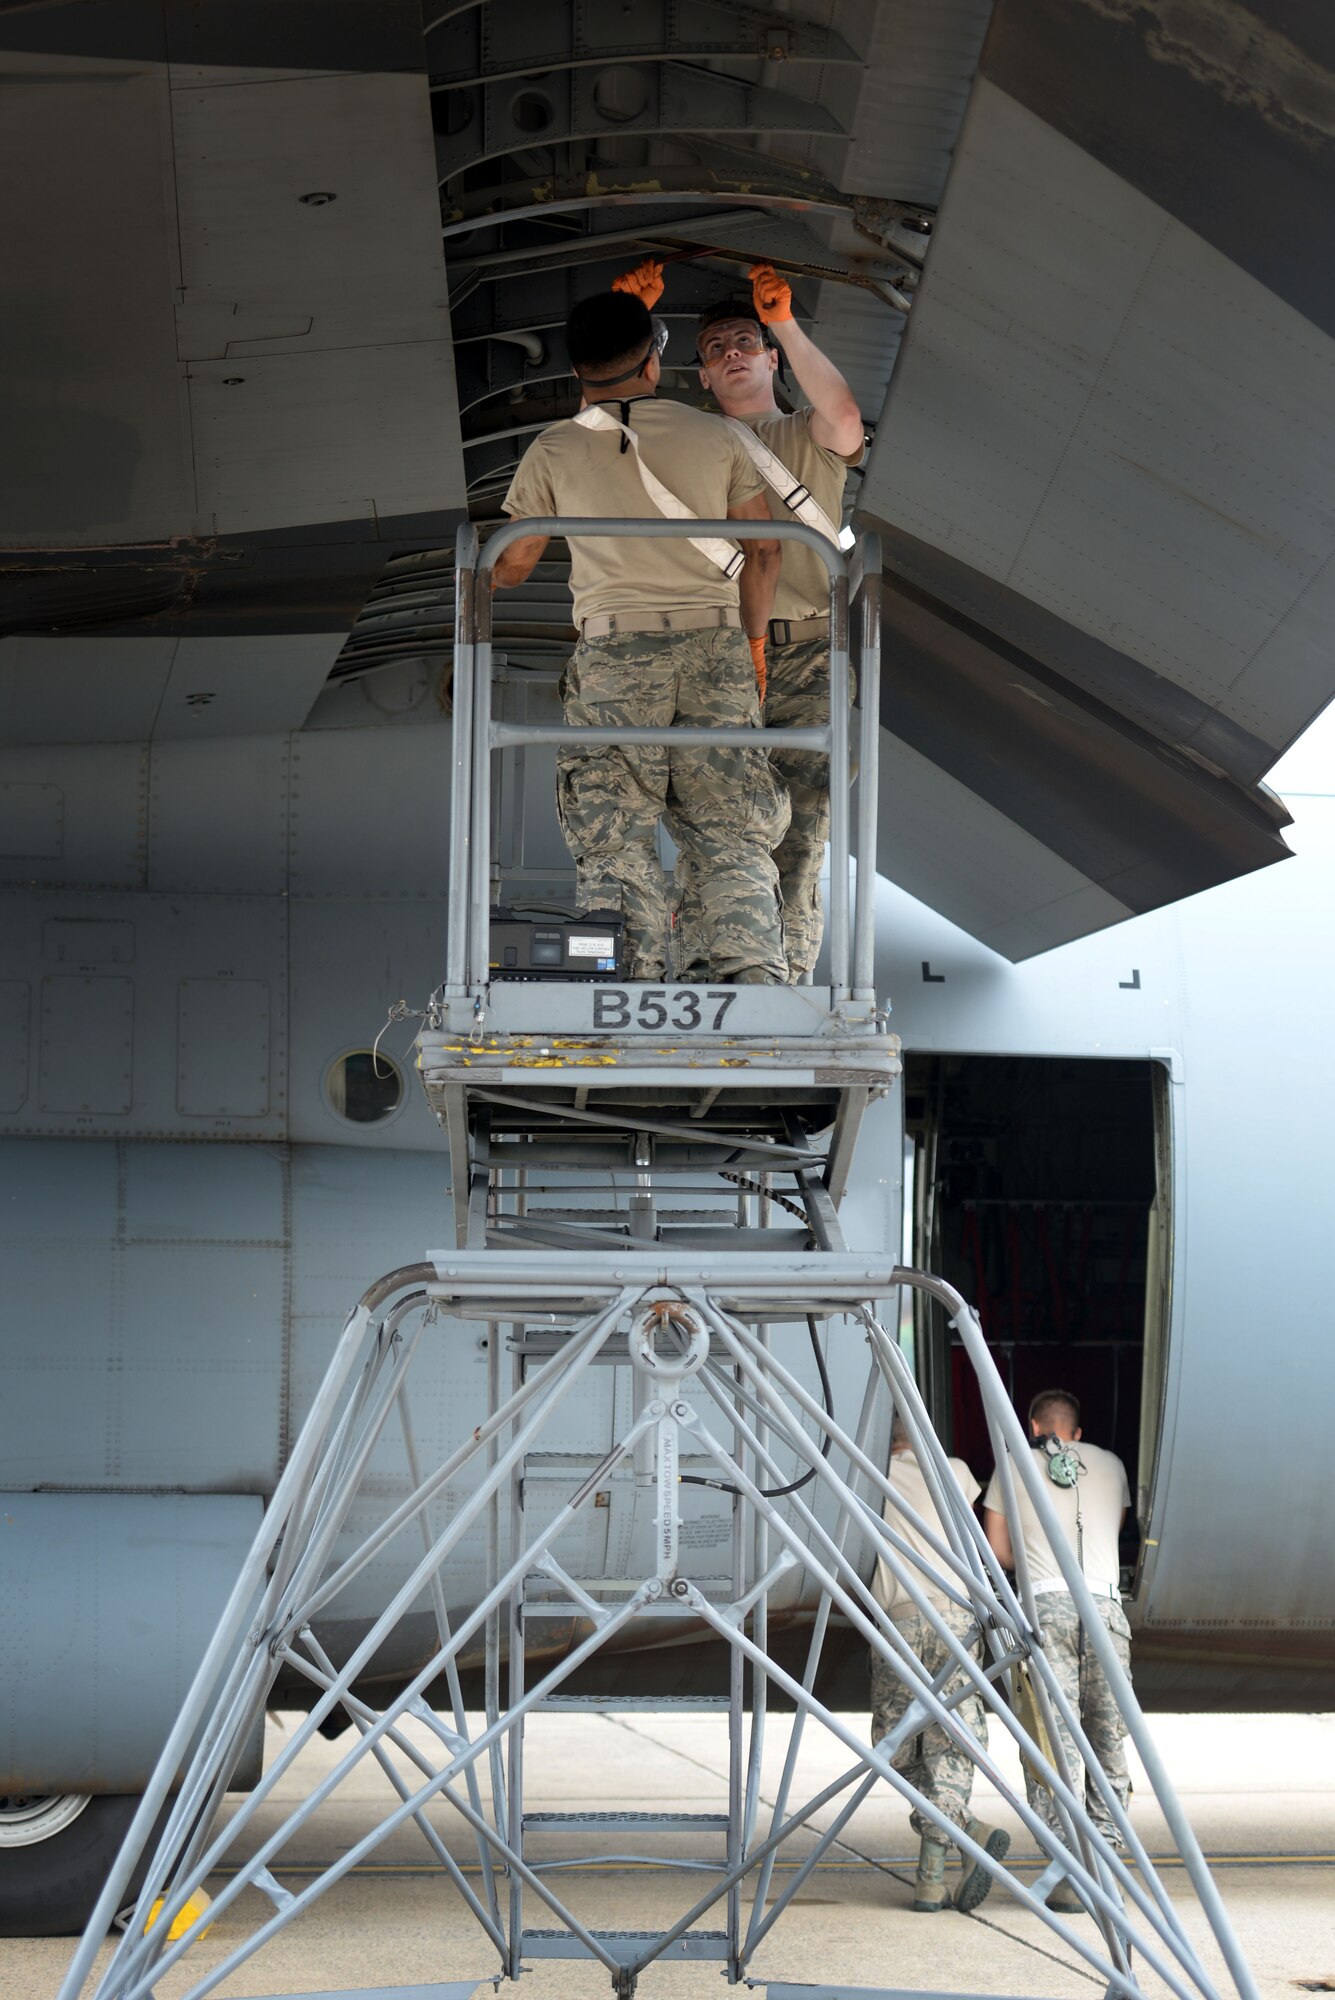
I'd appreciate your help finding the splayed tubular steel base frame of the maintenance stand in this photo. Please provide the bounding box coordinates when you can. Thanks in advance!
[62,1250,1255,2000]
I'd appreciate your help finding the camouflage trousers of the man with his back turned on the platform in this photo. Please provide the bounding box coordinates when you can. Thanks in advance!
[556,626,787,986]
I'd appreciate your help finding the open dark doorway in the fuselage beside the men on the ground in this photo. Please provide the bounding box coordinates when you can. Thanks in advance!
[905,1054,1171,1570]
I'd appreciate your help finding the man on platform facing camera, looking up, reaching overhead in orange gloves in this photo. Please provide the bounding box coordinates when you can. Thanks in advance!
[616,258,865,980]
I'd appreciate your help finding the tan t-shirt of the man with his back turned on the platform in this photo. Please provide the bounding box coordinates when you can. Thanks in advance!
[504,396,765,624]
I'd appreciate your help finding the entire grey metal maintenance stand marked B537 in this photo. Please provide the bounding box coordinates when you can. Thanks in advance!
[60,520,1255,2000]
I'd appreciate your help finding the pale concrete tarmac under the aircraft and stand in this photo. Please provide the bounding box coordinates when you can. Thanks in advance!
[18,1712,1335,2000]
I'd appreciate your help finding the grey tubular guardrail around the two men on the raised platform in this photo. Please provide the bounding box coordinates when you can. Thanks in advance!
[446,516,881,1004]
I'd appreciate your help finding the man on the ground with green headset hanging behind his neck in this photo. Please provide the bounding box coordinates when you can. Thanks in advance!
[983,1388,1131,1912]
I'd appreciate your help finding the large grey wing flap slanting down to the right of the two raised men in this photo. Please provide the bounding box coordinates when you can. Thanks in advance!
[859,0,1335,958]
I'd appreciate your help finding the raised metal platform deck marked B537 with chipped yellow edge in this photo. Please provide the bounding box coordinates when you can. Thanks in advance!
[418,986,901,1244]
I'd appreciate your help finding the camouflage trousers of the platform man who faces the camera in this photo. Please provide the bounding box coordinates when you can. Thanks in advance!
[677,638,851,984]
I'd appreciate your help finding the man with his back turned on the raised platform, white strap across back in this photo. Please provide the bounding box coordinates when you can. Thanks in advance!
[492,292,787,984]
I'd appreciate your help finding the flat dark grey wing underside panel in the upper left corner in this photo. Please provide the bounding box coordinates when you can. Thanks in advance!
[0,0,464,632]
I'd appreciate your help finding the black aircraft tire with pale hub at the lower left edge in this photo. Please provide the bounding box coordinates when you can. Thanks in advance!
[0,1792,140,1938]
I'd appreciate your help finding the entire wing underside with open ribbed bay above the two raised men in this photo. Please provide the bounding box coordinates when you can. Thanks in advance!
[0,0,1335,958]
